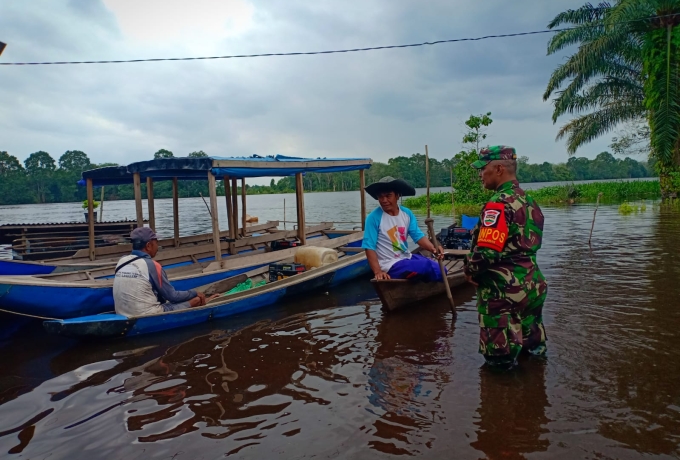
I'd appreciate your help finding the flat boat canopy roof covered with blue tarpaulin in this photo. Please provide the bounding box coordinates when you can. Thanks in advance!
[78,155,373,186]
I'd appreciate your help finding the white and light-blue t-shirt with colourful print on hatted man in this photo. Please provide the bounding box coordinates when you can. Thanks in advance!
[361,206,425,272]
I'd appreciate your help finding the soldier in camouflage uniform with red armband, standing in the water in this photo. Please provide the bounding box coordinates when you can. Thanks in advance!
[465,145,548,367]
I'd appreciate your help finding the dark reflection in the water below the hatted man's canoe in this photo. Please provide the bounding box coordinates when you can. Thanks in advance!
[368,305,454,455]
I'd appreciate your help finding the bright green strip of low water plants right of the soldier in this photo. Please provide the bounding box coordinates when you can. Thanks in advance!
[528,181,661,204]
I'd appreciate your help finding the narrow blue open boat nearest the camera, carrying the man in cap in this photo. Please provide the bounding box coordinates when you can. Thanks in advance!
[43,252,370,339]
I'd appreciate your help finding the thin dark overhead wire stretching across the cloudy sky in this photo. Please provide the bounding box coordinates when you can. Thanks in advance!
[0,13,680,66]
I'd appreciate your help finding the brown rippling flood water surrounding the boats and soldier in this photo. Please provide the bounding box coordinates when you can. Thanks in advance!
[0,192,680,460]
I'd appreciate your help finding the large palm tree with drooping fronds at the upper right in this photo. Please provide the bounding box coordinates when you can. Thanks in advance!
[543,0,680,197]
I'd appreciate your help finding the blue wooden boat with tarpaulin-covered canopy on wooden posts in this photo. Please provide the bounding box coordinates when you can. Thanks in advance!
[0,155,372,319]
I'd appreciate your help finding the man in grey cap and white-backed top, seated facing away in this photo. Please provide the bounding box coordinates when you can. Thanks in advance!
[113,227,210,317]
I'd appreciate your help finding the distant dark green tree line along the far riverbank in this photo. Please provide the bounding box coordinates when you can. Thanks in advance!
[0,149,654,205]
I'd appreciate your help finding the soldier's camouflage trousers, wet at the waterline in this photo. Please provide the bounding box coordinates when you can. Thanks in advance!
[479,295,546,365]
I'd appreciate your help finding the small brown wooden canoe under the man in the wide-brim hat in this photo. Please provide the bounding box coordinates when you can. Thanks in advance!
[371,251,465,311]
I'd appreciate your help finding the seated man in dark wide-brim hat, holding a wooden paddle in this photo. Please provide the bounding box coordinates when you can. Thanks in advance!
[362,176,444,281]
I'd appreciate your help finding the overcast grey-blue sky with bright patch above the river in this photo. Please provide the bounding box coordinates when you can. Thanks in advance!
[0,0,610,185]
